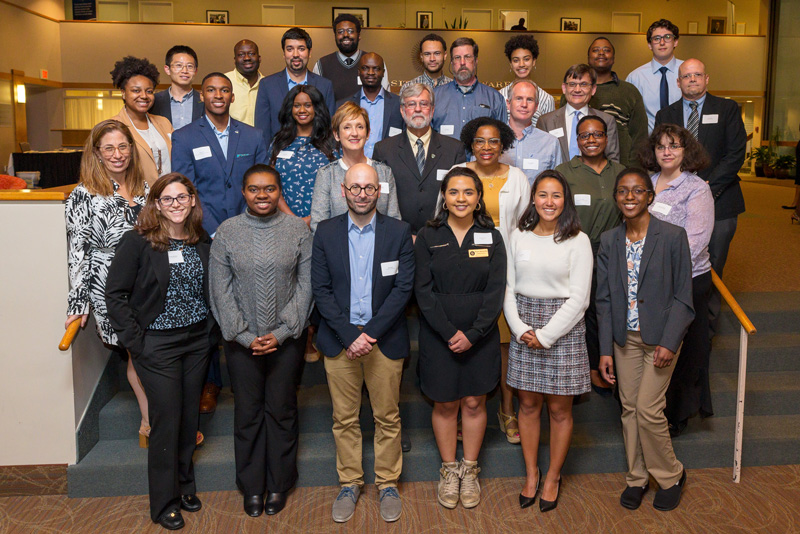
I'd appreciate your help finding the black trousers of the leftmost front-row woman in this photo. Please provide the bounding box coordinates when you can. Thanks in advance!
[133,321,209,521]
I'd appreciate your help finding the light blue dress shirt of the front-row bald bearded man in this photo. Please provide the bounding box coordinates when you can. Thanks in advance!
[347,213,376,326]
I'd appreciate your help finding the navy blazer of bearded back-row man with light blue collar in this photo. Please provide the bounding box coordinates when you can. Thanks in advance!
[255,69,336,145]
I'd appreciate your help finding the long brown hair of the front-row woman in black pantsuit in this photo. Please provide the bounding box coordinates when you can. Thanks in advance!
[134,172,205,252]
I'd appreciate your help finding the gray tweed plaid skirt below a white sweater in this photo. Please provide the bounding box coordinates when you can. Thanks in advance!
[507,295,590,395]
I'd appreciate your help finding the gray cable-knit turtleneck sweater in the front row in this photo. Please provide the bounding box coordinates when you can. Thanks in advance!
[209,207,313,347]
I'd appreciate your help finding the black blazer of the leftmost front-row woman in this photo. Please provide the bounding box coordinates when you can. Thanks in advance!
[106,230,219,356]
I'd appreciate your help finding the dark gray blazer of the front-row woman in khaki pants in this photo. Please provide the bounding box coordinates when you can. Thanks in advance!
[597,217,694,356]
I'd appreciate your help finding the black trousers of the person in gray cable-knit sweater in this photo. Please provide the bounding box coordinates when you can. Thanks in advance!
[225,336,308,495]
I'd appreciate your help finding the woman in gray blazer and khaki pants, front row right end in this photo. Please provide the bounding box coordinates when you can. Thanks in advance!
[597,169,694,511]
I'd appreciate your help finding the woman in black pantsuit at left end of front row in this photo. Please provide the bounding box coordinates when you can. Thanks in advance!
[106,173,220,530]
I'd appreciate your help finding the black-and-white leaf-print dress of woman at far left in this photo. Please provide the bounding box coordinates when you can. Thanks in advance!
[64,181,150,345]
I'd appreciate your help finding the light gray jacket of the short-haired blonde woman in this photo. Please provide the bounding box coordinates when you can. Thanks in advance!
[311,159,400,232]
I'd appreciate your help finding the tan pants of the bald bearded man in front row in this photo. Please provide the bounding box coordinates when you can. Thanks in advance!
[325,345,403,490]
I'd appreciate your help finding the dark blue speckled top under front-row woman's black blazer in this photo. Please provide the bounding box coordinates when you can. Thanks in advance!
[147,239,208,330]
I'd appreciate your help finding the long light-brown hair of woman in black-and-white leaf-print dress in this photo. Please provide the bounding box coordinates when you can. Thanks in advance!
[78,119,144,197]
